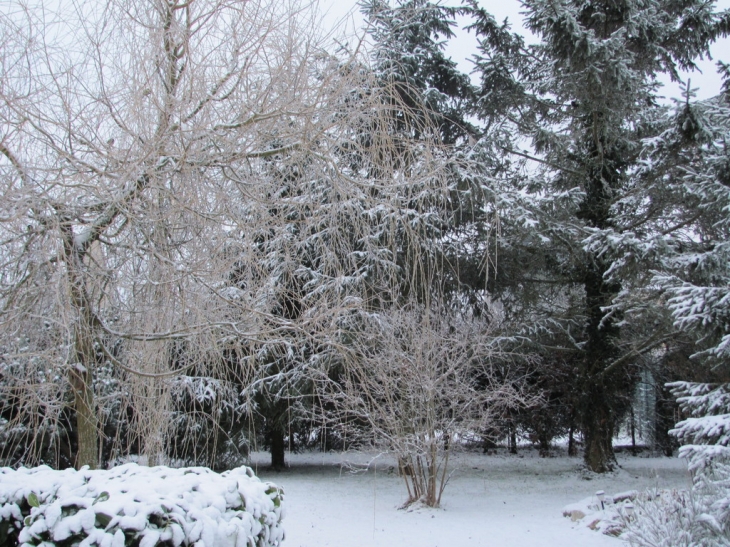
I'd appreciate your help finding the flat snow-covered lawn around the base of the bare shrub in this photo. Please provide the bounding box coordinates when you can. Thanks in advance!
[251,448,689,547]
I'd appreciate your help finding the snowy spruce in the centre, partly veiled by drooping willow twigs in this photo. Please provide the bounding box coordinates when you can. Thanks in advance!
[225,1,471,467]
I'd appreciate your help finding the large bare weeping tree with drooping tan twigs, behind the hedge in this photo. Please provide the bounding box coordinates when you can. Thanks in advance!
[0,0,464,467]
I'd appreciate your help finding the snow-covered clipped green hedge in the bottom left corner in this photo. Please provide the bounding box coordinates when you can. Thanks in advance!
[0,463,284,547]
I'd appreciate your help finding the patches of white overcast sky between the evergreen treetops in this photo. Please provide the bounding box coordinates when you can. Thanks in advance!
[320,0,730,99]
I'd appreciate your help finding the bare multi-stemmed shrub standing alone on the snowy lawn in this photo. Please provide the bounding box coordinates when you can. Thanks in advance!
[321,303,534,507]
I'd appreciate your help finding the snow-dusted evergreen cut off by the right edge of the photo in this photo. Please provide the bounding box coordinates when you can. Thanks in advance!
[625,69,730,468]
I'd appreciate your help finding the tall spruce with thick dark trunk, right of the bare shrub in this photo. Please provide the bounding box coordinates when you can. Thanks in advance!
[472,0,727,472]
